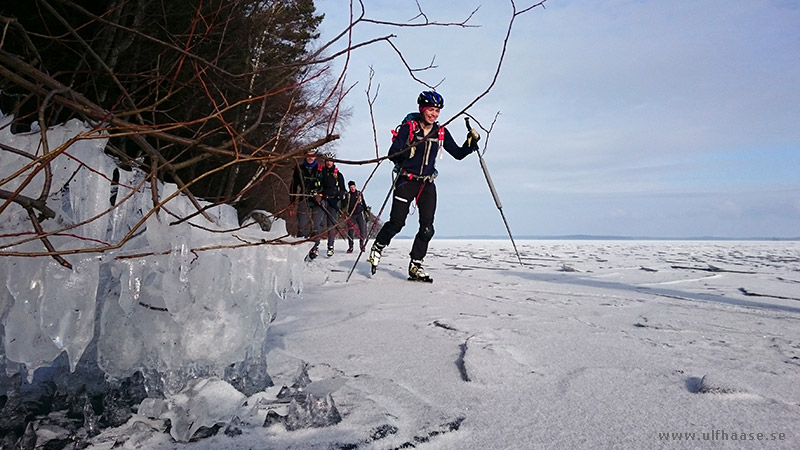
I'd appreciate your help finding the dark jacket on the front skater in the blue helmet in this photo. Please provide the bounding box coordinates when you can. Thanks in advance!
[389,119,476,176]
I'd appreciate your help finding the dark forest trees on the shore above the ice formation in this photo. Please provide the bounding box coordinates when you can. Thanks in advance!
[0,0,338,225]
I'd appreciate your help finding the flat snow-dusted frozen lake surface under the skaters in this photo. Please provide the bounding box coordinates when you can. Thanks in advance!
[98,238,800,450]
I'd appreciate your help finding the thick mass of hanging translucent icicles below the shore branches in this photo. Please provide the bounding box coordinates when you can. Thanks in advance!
[0,113,302,437]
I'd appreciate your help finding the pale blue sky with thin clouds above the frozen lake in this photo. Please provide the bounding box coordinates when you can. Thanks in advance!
[316,0,800,238]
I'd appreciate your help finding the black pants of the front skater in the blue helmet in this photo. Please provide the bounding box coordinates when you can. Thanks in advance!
[375,179,436,260]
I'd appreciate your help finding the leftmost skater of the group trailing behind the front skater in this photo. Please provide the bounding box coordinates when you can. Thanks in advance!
[289,151,325,260]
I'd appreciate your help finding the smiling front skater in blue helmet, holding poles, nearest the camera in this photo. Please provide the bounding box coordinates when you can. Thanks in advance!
[369,91,480,282]
